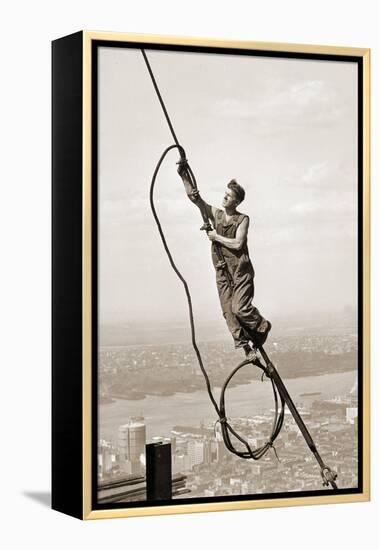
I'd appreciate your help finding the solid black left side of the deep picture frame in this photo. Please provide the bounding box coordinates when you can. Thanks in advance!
[51,32,83,519]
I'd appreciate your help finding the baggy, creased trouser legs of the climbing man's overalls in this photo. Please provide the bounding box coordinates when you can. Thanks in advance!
[217,272,264,348]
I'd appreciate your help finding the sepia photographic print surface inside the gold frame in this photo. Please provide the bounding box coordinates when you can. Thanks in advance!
[97,46,360,505]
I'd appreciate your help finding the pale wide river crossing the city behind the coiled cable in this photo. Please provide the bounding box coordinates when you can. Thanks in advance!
[99,371,357,443]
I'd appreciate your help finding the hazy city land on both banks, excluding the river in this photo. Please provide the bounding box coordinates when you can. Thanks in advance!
[98,333,358,502]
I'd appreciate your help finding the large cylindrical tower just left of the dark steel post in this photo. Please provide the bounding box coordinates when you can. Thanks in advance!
[118,417,146,474]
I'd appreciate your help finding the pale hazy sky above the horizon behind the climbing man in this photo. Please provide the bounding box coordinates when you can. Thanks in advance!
[99,48,357,323]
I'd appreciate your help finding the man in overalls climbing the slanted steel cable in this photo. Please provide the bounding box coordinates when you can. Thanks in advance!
[178,159,271,360]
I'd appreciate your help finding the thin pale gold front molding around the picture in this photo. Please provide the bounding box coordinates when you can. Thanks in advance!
[82,31,370,519]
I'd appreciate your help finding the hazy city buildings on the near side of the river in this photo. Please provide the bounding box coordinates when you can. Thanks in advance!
[99,386,358,502]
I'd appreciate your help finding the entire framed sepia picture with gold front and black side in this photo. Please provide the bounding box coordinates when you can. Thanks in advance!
[52,31,370,519]
